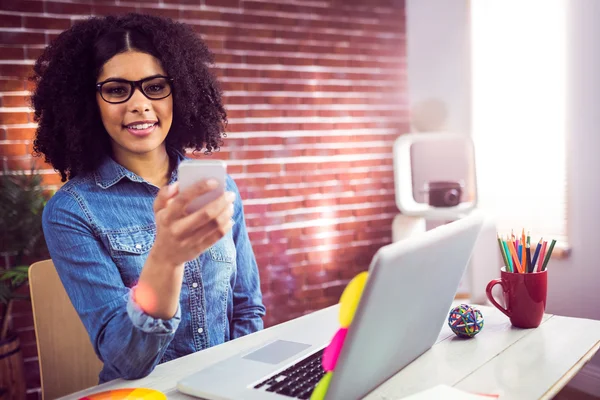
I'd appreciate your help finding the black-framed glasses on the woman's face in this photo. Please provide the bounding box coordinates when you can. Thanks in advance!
[96,75,173,104]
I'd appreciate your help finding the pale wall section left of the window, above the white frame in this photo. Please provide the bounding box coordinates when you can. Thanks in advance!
[406,0,471,134]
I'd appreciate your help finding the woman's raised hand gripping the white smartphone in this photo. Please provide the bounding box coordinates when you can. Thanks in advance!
[149,180,235,267]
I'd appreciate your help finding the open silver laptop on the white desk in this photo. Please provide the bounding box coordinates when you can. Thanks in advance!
[177,212,484,400]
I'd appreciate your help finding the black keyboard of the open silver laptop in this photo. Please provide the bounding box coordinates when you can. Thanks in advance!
[254,349,325,399]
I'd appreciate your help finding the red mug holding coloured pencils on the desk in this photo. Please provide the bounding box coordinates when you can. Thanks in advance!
[485,268,548,328]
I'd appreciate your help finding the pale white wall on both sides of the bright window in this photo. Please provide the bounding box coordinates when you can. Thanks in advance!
[406,0,600,384]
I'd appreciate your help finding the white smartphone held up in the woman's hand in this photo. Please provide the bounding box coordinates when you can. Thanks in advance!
[177,160,227,213]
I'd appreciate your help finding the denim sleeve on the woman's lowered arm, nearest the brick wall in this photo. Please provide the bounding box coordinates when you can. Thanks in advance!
[230,178,265,339]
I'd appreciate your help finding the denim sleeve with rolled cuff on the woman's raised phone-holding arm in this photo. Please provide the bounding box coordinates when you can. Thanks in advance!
[43,190,181,379]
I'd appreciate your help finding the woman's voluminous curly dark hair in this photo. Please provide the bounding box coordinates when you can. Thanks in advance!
[31,14,227,182]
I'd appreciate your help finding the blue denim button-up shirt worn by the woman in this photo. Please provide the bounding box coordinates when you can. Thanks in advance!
[43,153,265,383]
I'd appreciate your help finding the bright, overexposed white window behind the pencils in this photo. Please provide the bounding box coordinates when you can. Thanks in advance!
[470,0,567,248]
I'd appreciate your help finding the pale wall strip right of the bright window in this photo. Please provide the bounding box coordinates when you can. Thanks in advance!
[548,0,600,319]
